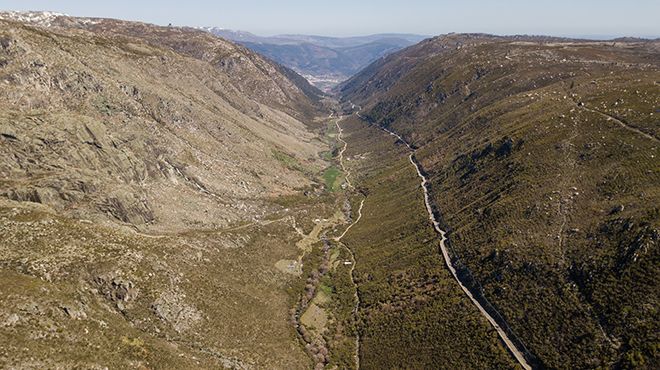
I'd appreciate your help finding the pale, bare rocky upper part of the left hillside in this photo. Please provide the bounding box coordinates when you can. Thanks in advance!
[0,17,330,233]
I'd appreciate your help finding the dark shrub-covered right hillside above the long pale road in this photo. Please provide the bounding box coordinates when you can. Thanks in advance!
[340,35,660,368]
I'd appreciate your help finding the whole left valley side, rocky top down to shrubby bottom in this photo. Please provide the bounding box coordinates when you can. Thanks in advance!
[0,15,334,368]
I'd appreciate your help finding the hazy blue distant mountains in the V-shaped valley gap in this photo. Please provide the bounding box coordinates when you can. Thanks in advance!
[204,27,426,90]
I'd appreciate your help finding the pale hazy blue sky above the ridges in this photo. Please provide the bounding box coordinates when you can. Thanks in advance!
[0,0,660,37]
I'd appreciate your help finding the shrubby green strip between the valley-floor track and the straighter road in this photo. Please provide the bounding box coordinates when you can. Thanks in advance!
[341,116,515,369]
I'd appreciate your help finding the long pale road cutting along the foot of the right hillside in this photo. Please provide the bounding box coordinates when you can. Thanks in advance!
[368,113,532,370]
